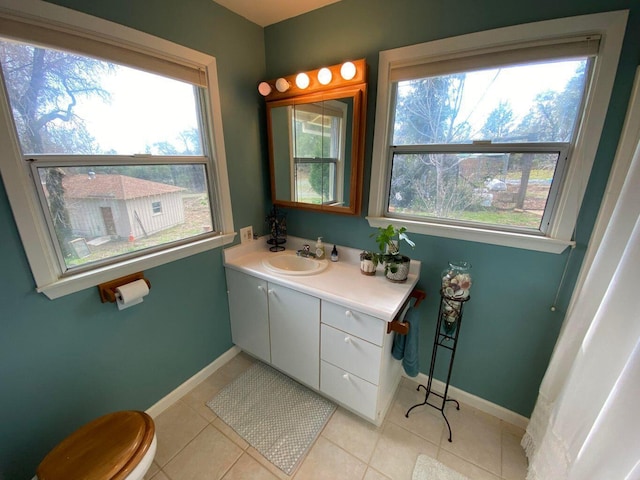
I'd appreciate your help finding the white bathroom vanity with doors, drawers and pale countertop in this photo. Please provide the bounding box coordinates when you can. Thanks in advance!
[224,242,420,425]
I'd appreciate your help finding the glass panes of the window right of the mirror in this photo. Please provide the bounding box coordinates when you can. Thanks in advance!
[388,59,587,229]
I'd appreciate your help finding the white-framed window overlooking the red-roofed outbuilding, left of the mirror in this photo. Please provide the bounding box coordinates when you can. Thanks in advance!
[0,1,233,298]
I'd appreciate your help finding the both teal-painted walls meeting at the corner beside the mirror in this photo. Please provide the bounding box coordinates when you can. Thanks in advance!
[0,0,640,480]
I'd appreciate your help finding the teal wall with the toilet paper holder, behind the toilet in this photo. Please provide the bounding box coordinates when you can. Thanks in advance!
[0,0,269,480]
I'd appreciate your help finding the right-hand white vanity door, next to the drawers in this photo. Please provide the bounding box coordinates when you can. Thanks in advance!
[269,284,320,390]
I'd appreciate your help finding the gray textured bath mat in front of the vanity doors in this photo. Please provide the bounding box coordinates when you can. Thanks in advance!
[207,362,336,475]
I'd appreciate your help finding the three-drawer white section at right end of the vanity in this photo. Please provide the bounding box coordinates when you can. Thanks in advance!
[320,301,401,425]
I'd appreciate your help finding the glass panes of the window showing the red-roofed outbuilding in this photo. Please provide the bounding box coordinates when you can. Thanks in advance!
[0,39,213,268]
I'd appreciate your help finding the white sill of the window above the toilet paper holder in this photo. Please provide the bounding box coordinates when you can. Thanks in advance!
[36,232,236,300]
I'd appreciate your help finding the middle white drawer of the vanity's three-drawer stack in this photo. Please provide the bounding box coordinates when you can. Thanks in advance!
[320,325,382,385]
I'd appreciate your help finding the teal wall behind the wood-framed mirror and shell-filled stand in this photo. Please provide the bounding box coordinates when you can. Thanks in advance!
[265,0,640,416]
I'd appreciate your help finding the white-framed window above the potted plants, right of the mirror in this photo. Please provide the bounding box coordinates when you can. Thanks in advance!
[368,12,626,253]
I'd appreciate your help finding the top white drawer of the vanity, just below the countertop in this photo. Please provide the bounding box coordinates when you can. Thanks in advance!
[322,301,387,345]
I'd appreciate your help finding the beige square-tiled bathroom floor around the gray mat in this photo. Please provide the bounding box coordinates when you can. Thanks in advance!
[145,354,527,480]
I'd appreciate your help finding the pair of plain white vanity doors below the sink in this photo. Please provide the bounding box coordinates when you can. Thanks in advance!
[226,268,320,390]
